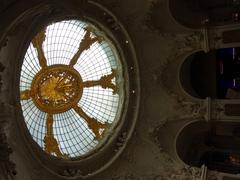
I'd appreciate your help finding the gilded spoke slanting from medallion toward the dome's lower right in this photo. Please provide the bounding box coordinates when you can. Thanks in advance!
[73,106,110,140]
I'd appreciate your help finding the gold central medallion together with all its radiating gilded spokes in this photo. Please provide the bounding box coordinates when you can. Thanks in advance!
[20,27,118,158]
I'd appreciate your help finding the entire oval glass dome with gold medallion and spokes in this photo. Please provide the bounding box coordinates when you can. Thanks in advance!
[20,20,124,158]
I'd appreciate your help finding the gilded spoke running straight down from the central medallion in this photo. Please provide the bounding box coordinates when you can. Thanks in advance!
[44,114,65,158]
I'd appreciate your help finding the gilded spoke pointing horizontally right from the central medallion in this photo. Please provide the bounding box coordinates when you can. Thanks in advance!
[83,69,118,94]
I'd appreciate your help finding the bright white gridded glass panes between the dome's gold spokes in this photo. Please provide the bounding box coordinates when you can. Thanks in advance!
[20,20,124,158]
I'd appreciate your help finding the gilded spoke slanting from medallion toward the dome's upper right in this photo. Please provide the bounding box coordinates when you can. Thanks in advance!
[69,27,103,67]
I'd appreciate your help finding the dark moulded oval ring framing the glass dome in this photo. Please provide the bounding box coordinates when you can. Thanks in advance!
[2,0,140,177]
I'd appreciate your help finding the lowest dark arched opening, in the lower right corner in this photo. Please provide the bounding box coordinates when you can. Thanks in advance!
[176,121,240,174]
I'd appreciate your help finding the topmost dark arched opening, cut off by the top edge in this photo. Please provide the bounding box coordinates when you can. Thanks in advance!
[170,0,240,28]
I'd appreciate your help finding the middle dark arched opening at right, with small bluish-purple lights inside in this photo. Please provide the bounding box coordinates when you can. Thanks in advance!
[180,47,240,99]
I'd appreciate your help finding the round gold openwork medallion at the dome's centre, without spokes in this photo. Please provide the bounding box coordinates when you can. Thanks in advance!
[31,64,83,114]
